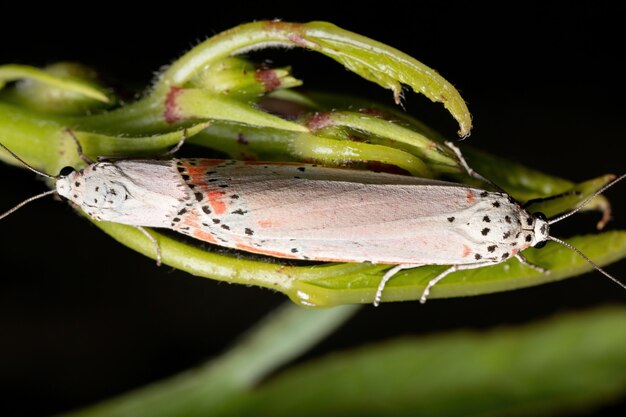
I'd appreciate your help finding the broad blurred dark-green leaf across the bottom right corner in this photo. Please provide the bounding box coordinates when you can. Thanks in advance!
[233,308,626,417]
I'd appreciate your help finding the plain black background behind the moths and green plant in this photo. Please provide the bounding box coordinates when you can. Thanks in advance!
[0,1,626,416]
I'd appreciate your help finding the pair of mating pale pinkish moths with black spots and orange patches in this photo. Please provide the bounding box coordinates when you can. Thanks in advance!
[0,141,626,305]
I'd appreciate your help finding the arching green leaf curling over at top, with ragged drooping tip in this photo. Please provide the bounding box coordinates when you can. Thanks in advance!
[155,21,472,136]
